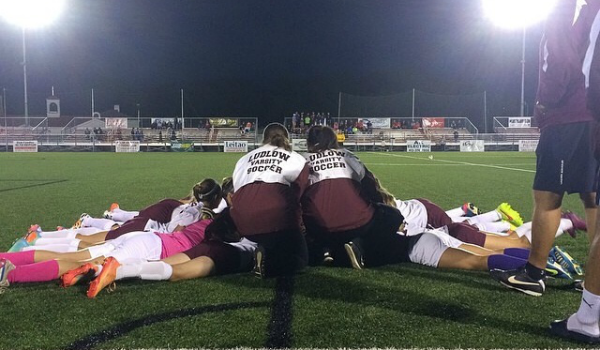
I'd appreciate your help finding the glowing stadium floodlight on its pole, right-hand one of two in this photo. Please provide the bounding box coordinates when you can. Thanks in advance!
[482,0,557,117]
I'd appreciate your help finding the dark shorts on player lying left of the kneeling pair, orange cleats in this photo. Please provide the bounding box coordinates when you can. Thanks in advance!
[183,241,252,275]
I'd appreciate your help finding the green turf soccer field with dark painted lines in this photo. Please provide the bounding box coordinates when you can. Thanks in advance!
[0,152,587,349]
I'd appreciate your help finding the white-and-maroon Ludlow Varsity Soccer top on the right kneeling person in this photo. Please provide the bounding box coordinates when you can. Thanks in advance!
[302,148,374,232]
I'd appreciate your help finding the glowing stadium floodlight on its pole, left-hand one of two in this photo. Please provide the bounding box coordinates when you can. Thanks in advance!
[0,0,66,126]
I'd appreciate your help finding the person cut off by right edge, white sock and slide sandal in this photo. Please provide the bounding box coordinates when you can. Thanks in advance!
[550,2,600,344]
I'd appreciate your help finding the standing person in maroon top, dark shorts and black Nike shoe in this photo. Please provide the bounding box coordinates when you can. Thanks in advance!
[491,0,598,296]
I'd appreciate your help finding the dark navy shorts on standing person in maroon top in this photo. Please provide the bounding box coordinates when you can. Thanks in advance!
[533,122,598,194]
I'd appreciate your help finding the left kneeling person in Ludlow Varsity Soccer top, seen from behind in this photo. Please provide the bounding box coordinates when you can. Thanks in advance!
[231,123,308,278]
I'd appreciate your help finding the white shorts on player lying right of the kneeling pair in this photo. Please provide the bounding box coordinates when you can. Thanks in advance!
[408,230,464,267]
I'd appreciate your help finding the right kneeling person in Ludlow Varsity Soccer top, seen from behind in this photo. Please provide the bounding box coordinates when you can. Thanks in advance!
[302,125,408,269]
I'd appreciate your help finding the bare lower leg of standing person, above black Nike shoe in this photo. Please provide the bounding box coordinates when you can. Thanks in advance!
[529,190,563,270]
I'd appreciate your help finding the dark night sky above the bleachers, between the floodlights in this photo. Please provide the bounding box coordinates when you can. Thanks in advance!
[0,0,542,126]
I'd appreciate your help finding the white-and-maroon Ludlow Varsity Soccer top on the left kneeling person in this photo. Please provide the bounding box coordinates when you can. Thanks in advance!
[231,145,308,236]
